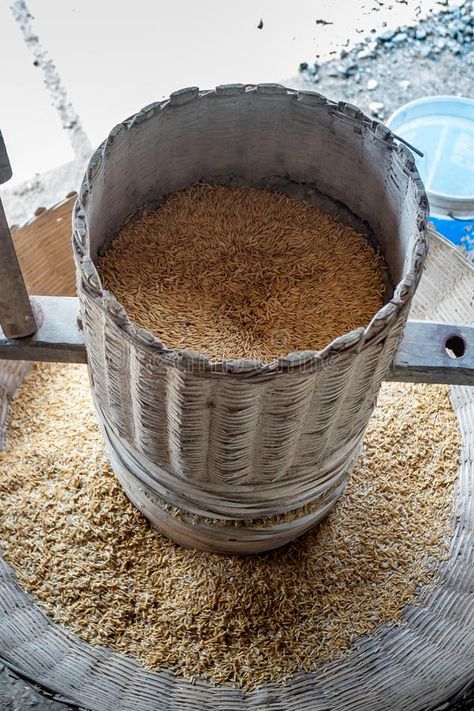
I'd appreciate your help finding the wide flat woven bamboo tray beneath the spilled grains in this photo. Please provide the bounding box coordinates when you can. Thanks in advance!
[0,213,474,711]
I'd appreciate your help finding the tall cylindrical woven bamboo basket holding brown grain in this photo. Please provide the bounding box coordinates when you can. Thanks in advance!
[73,84,427,553]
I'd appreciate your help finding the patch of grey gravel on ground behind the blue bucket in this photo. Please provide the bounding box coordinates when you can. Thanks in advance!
[292,0,474,121]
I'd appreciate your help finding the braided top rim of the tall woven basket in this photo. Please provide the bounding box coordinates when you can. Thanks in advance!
[72,84,429,378]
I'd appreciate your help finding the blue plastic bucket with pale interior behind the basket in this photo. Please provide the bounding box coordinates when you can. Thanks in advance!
[387,96,474,251]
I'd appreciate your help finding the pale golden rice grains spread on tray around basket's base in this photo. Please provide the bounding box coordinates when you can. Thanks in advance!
[0,364,460,689]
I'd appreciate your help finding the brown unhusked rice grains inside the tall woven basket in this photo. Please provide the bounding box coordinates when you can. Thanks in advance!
[98,185,385,362]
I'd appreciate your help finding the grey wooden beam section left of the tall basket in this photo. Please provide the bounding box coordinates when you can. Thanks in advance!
[0,296,87,363]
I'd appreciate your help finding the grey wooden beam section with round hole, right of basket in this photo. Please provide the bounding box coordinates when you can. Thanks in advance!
[386,321,474,385]
